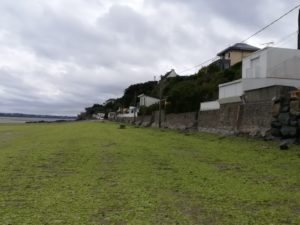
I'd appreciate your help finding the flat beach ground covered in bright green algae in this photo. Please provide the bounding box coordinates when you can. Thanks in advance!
[0,122,300,225]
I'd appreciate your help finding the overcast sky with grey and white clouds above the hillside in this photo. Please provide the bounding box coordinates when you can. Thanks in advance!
[0,0,300,115]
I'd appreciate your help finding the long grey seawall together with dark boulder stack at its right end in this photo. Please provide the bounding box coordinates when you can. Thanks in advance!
[113,86,300,138]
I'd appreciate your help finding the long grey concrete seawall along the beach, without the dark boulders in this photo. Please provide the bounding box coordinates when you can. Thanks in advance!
[112,86,292,136]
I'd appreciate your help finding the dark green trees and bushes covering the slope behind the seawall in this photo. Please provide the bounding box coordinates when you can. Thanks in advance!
[78,60,242,119]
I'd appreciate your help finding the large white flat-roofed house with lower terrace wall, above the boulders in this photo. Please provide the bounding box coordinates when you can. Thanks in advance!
[219,47,300,104]
